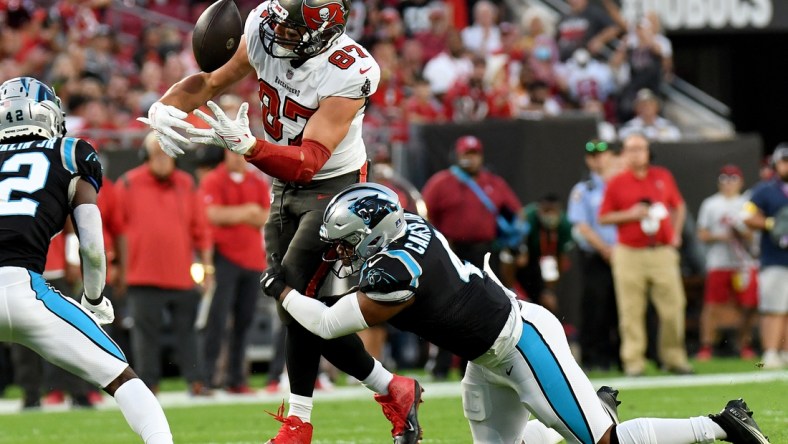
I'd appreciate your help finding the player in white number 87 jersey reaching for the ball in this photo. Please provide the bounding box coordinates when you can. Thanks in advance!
[143,0,422,444]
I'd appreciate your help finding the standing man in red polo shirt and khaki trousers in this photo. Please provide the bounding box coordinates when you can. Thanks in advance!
[599,134,692,376]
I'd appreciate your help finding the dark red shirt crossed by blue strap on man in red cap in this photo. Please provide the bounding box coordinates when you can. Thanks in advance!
[422,170,522,242]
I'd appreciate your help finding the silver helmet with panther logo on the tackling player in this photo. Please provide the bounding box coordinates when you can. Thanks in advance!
[320,183,405,274]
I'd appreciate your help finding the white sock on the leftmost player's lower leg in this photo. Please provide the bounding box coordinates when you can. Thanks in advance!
[115,378,172,444]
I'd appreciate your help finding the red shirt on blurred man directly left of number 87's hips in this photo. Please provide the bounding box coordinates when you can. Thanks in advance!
[200,164,271,271]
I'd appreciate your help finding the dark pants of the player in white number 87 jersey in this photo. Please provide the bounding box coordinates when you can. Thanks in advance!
[264,165,367,296]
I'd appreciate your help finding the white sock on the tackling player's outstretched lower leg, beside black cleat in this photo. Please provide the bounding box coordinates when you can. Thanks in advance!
[616,416,727,444]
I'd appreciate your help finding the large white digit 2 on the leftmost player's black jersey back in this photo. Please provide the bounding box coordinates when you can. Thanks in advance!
[0,152,50,216]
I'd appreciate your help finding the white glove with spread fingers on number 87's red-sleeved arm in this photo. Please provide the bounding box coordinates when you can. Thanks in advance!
[186,101,257,154]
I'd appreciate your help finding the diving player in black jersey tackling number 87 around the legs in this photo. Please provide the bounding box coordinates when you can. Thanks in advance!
[261,184,768,444]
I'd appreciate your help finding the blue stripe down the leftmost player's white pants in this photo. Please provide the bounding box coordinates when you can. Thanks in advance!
[28,270,128,362]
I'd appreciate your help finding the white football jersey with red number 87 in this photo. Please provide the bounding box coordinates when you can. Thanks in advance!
[244,2,380,180]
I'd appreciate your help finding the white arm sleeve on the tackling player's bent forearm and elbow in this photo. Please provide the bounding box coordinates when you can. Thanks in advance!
[282,290,368,339]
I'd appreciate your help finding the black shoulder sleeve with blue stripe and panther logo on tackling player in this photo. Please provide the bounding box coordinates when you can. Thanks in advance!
[359,250,422,302]
